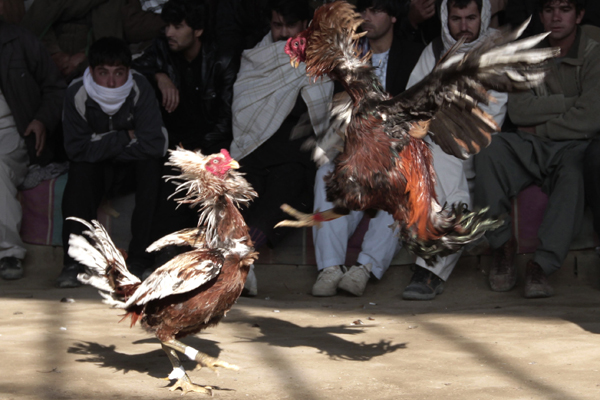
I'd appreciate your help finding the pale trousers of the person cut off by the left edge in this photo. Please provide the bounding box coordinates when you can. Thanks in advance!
[0,141,29,259]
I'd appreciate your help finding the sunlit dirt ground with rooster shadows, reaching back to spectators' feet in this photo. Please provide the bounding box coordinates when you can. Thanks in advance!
[0,247,600,400]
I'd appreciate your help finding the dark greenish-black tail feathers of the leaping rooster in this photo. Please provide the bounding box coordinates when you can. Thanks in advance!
[402,203,504,265]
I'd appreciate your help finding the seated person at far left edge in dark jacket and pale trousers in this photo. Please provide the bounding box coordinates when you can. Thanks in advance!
[0,0,65,279]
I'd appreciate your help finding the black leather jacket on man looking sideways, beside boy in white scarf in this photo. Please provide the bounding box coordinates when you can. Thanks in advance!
[134,37,239,153]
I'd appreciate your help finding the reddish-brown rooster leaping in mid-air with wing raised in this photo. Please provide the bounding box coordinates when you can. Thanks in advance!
[278,1,559,262]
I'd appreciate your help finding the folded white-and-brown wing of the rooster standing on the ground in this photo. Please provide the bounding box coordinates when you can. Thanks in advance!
[124,250,224,308]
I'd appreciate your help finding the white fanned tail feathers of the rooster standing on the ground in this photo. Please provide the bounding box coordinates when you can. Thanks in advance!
[67,217,140,308]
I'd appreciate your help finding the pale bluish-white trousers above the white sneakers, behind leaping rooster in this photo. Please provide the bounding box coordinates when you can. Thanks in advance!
[313,162,400,279]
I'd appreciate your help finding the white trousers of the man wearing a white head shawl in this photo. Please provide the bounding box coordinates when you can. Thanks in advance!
[416,142,472,281]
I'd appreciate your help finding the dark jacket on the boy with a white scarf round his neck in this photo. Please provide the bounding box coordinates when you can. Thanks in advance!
[63,71,168,163]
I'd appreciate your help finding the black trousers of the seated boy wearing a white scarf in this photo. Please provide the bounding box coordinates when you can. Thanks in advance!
[62,159,162,266]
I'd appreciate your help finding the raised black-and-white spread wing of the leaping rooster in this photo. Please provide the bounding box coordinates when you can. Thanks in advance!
[377,21,559,159]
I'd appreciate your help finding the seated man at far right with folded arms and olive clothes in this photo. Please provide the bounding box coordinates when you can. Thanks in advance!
[475,0,600,298]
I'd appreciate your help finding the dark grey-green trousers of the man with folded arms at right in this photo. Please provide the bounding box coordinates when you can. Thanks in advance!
[474,131,588,274]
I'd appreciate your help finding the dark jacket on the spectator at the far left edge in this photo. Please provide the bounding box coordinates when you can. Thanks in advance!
[0,21,66,164]
